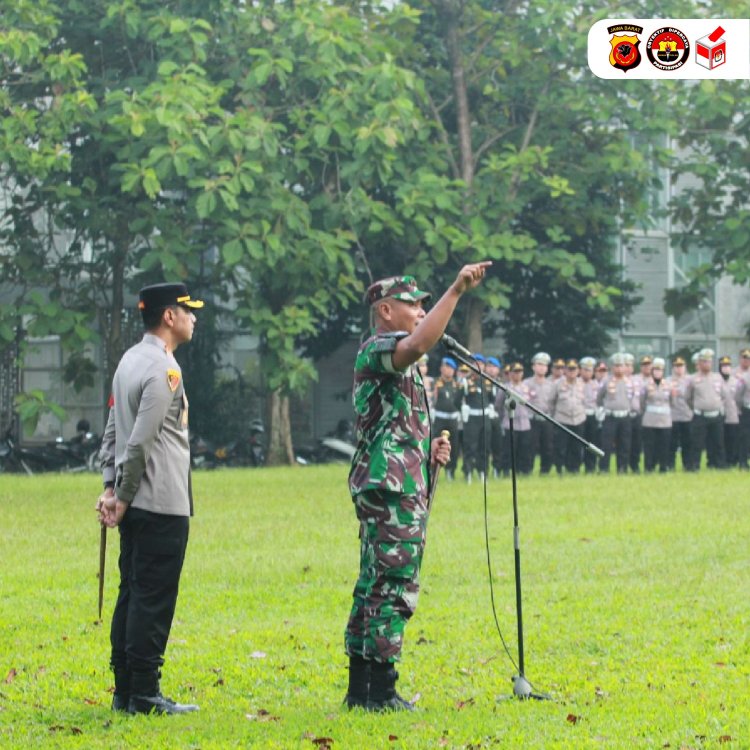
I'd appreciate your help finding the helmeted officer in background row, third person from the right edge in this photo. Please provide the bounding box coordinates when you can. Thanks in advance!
[686,348,726,471]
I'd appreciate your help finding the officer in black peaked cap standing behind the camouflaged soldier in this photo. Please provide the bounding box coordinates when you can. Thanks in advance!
[97,283,203,714]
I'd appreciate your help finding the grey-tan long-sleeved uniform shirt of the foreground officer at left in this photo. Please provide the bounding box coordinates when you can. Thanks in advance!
[99,333,192,516]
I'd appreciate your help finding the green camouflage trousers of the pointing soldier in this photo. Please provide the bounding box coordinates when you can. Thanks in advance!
[344,490,427,662]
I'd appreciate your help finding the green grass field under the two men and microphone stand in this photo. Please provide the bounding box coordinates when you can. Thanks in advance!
[0,466,750,750]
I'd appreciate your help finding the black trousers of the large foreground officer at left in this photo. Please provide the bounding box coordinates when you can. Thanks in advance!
[110,508,190,672]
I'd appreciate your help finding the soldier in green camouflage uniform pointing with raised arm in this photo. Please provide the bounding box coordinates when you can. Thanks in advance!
[345,262,490,711]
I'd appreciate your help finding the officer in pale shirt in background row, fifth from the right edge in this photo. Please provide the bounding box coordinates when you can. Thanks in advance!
[638,357,672,472]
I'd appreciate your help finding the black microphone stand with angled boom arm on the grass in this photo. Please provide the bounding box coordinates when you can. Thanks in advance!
[443,344,604,700]
